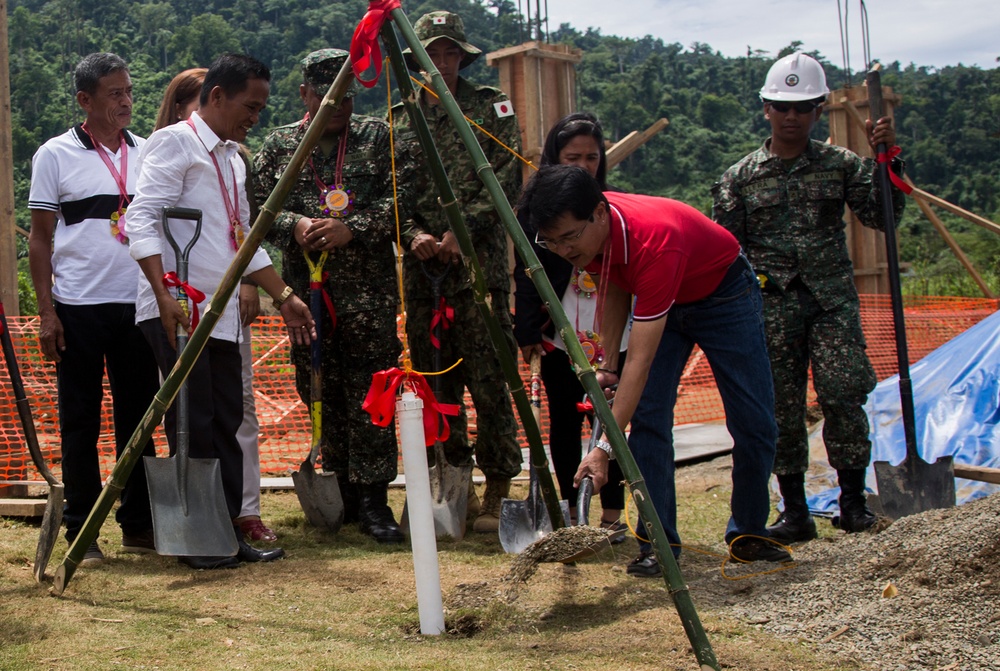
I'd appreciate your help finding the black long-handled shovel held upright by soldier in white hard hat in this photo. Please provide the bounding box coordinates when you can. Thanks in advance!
[865,69,955,520]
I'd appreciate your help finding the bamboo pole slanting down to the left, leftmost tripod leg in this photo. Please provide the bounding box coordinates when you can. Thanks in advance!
[52,59,354,595]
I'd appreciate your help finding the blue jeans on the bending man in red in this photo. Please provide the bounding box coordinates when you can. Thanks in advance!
[629,254,778,556]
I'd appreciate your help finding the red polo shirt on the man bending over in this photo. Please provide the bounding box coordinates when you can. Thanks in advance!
[587,192,740,321]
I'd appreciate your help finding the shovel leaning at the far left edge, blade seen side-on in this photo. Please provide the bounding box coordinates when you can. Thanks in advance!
[0,301,64,582]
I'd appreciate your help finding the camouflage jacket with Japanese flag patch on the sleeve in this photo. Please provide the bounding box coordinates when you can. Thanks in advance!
[392,77,521,298]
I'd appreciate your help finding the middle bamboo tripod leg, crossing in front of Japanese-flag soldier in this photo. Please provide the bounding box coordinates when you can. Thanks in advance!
[382,23,566,529]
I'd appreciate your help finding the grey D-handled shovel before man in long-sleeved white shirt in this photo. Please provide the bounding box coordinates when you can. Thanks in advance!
[143,207,238,557]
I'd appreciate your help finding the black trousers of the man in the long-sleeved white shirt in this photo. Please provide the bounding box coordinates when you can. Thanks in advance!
[139,318,243,519]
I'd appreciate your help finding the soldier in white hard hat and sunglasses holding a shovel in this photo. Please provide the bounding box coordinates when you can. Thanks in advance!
[712,53,904,543]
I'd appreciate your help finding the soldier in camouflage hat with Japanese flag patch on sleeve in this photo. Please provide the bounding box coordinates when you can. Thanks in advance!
[393,11,521,532]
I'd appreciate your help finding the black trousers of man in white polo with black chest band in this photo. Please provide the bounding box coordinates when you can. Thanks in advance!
[55,303,160,542]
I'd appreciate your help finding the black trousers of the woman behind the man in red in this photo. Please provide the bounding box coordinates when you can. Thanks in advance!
[542,349,625,510]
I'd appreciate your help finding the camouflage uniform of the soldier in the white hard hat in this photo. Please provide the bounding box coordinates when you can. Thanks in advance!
[712,140,904,475]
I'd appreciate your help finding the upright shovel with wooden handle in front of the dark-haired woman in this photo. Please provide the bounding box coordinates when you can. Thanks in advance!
[499,352,570,554]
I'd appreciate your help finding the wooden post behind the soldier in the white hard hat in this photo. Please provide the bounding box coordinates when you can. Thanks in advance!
[826,86,900,294]
